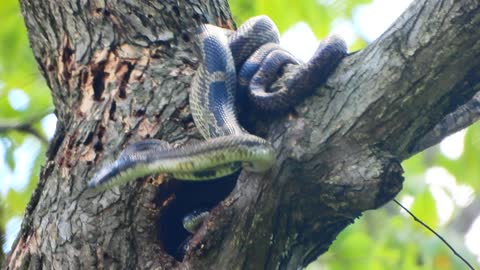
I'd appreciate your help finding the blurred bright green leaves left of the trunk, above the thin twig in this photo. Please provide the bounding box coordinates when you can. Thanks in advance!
[0,0,52,121]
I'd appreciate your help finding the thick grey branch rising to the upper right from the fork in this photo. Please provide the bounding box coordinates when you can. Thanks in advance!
[191,1,480,269]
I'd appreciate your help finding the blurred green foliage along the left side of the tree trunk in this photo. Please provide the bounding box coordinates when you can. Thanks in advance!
[0,0,52,255]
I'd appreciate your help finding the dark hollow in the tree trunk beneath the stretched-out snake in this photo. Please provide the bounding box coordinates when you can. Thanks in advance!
[157,173,239,261]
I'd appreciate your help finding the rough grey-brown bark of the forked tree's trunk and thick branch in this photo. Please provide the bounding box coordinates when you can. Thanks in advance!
[7,0,480,269]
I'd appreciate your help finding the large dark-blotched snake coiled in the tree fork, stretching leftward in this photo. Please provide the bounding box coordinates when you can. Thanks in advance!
[89,16,346,192]
